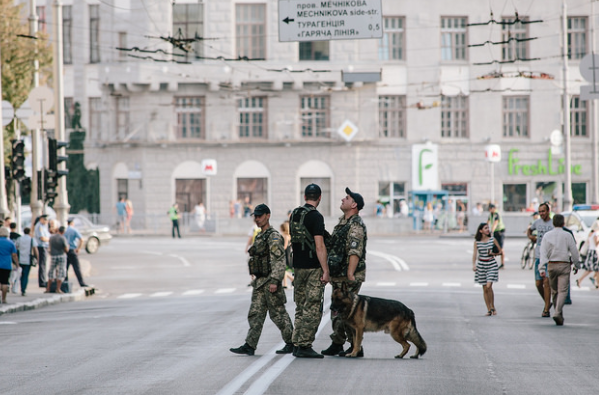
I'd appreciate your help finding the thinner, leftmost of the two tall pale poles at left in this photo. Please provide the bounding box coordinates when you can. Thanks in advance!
[29,0,43,219]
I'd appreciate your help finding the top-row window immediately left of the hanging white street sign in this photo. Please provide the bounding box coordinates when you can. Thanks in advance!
[235,4,266,59]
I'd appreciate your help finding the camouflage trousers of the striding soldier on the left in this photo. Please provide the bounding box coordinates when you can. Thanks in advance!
[245,284,293,349]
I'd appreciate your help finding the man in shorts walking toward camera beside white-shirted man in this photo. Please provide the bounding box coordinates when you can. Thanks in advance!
[526,203,554,317]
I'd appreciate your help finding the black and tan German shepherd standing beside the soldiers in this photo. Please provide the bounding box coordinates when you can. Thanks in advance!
[331,283,426,358]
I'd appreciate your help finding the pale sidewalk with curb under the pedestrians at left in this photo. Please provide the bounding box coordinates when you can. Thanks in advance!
[0,259,95,316]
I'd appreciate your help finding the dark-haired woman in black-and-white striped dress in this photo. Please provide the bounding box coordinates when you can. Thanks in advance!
[472,222,503,316]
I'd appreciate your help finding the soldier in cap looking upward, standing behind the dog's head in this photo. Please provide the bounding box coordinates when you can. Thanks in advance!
[321,188,368,357]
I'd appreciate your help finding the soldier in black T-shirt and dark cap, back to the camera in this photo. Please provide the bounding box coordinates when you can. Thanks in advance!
[289,184,329,358]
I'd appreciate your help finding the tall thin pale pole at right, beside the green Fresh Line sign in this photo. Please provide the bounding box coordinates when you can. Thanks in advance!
[562,0,572,211]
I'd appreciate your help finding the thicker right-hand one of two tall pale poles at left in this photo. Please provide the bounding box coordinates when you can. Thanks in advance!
[52,0,71,225]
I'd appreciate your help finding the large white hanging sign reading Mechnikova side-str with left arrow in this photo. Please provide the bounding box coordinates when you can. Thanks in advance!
[279,0,383,42]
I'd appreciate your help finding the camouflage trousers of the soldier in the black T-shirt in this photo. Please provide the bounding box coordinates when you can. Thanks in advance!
[293,269,324,347]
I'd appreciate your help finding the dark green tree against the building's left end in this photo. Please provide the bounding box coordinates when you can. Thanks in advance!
[67,131,100,214]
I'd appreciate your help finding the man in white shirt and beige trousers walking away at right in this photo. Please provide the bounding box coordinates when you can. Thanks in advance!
[539,215,580,326]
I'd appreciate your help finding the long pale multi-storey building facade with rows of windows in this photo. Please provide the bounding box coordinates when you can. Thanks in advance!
[29,0,597,226]
